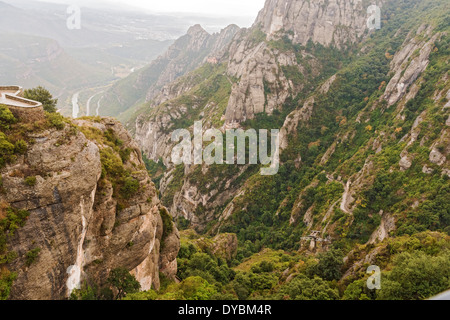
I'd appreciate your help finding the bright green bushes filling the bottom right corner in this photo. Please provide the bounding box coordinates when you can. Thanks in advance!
[343,231,450,300]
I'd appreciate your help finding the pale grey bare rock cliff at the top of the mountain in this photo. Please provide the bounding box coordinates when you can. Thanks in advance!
[225,0,381,128]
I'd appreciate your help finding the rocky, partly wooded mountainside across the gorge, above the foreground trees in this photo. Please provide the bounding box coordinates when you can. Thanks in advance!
[127,0,450,298]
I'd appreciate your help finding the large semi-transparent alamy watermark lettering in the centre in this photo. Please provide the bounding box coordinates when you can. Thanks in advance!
[172,121,280,176]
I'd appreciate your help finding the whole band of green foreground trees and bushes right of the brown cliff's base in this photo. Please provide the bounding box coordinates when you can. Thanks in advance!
[167,232,450,300]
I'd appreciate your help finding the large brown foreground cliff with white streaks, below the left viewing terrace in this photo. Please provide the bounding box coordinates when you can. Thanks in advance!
[0,119,179,300]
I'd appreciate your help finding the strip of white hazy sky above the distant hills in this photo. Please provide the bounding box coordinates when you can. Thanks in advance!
[35,0,265,18]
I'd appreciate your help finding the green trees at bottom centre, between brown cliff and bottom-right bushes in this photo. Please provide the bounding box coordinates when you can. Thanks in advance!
[172,234,348,300]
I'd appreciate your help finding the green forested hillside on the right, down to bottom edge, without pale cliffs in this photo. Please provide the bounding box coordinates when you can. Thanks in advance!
[132,0,450,299]
